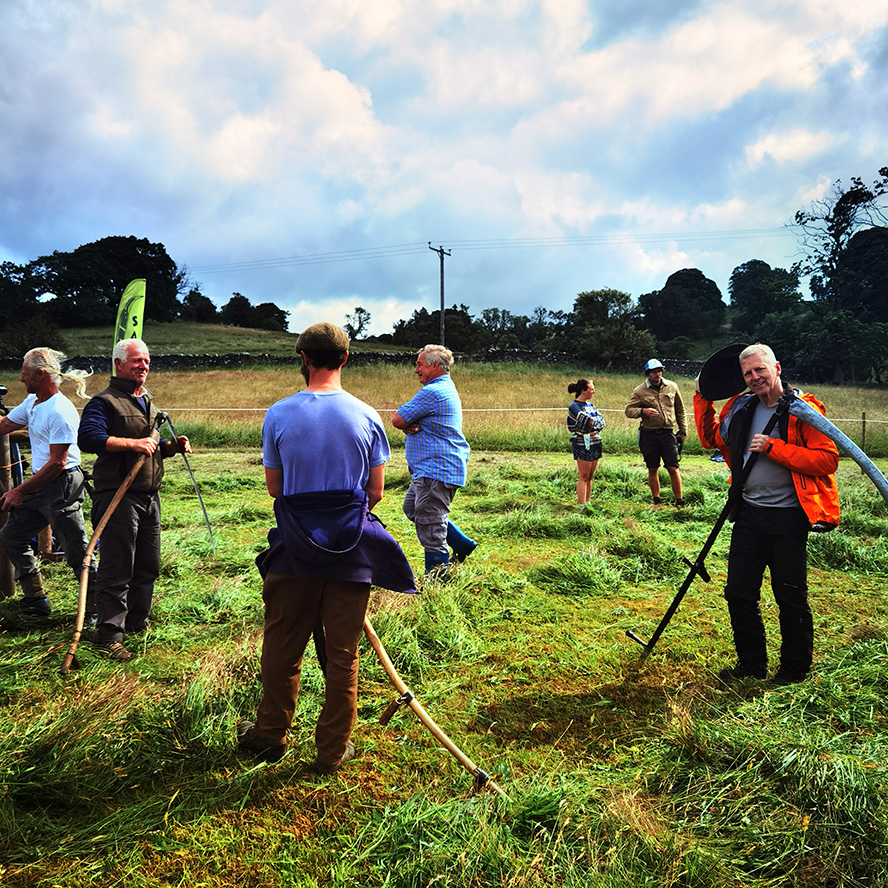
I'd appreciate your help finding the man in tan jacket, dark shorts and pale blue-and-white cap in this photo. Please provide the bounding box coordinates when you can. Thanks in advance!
[626,358,688,509]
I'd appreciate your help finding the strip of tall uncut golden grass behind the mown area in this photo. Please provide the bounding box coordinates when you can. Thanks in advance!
[6,358,888,458]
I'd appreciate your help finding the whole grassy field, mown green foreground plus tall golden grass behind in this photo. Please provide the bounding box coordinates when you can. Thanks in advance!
[0,364,888,888]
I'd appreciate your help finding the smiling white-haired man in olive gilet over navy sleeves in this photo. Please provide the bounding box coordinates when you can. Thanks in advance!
[77,339,191,661]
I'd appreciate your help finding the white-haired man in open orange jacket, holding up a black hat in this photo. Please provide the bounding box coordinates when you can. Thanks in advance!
[694,343,839,684]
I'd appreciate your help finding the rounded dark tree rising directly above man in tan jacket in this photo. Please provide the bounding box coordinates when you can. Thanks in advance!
[638,268,727,342]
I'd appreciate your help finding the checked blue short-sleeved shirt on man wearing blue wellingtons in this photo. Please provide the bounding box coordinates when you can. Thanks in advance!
[398,373,469,487]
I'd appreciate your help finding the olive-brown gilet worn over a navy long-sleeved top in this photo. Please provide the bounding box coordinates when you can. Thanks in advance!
[93,377,163,493]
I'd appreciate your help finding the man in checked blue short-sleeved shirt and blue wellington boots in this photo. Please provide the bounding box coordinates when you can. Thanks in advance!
[392,345,478,575]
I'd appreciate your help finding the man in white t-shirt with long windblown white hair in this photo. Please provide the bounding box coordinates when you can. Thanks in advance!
[0,347,95,625]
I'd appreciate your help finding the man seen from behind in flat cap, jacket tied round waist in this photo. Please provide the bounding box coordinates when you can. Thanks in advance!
[237,323,416,774]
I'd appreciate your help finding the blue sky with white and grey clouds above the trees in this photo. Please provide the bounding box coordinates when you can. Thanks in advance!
[0,0,888,333]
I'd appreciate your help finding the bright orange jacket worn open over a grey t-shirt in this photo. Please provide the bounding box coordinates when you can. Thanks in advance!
[694,389,839,526]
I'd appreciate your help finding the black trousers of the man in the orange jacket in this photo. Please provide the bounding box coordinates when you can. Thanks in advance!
[725,502,814,678]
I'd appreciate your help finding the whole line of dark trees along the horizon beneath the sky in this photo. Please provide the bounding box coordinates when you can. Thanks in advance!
[0,167,888,382]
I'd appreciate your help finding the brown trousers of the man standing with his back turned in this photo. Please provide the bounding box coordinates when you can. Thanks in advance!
[256,573,370,765]
